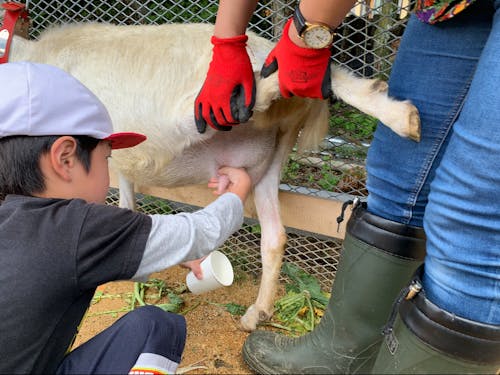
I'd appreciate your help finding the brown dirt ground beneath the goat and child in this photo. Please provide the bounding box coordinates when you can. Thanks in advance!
[74,267,284,374]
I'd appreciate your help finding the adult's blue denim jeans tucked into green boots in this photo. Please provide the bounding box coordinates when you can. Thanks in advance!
[367,0,500,324]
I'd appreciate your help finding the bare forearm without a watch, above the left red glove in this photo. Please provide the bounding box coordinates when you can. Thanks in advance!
[214,0,258,38]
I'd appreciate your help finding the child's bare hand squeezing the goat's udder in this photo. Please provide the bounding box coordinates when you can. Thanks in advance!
[208,167,252,203]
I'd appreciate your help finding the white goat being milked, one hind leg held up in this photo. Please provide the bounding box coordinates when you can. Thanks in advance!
[10,23,420,330]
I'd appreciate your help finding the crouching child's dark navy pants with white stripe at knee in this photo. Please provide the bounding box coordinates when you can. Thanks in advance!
[57,306,186,374]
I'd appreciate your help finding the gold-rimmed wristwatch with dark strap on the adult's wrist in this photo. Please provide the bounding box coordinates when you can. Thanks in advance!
[293,4,335,49]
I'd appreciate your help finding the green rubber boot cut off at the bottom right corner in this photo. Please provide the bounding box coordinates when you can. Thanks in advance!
[373,277,500,374]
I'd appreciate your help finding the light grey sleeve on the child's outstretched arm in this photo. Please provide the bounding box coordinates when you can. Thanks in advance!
[132,193,243,280]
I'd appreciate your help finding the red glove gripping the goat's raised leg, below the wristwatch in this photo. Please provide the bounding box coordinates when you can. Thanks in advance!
[260,19,333,99]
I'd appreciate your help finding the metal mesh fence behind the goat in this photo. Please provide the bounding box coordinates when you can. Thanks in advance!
[0,0,413,288]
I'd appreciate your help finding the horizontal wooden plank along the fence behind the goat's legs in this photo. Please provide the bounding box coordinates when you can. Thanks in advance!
[111,176,351,239]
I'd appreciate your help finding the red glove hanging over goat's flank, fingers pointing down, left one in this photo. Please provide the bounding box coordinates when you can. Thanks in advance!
[194,35,255,133]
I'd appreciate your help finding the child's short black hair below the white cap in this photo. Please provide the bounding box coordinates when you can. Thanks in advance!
[0,135,100,199]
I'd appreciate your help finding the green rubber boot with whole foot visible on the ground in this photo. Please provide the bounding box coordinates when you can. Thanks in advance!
[243,205,425,374]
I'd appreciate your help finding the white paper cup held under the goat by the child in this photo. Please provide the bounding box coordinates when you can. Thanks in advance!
[186,250,234,294]
